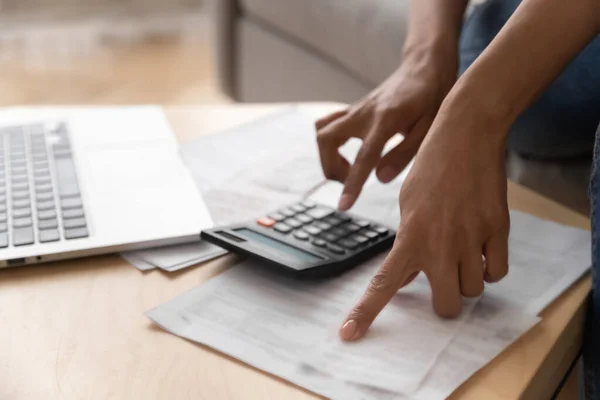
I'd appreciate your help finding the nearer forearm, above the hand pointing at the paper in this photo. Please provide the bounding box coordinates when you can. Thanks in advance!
[446,0,600,129]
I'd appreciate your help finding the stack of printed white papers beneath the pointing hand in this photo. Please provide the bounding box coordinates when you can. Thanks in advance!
[147,180,591,400]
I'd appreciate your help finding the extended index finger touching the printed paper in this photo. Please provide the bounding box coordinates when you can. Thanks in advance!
[340,244,418,341]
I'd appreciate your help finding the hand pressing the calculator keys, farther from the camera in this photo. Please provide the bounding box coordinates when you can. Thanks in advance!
[316,51,457,210]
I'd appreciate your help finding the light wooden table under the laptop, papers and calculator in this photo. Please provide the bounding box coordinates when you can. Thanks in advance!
[0,104,590,400]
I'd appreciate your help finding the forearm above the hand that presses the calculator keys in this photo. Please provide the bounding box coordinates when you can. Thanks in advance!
[403,0,468,91]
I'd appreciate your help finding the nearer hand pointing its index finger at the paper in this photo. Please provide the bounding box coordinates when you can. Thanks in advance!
[340,96,510,340]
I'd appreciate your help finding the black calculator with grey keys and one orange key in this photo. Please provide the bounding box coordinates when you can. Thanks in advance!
[200,200,395,278]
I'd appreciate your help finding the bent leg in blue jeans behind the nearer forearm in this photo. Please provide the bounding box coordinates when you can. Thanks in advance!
[460,0,600,159]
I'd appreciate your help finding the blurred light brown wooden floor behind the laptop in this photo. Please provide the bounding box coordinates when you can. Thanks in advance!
[0,38,229,107]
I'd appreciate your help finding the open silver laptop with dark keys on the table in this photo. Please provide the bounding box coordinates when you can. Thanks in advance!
[0,107,212,268]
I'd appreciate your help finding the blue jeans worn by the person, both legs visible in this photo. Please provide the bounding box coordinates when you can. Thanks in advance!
[460,0,600,400]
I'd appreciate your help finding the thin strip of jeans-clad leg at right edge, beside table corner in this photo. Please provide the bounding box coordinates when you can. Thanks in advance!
[583,126,600,400]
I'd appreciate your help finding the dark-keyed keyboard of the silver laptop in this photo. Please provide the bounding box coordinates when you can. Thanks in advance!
[0,124,89,248]
